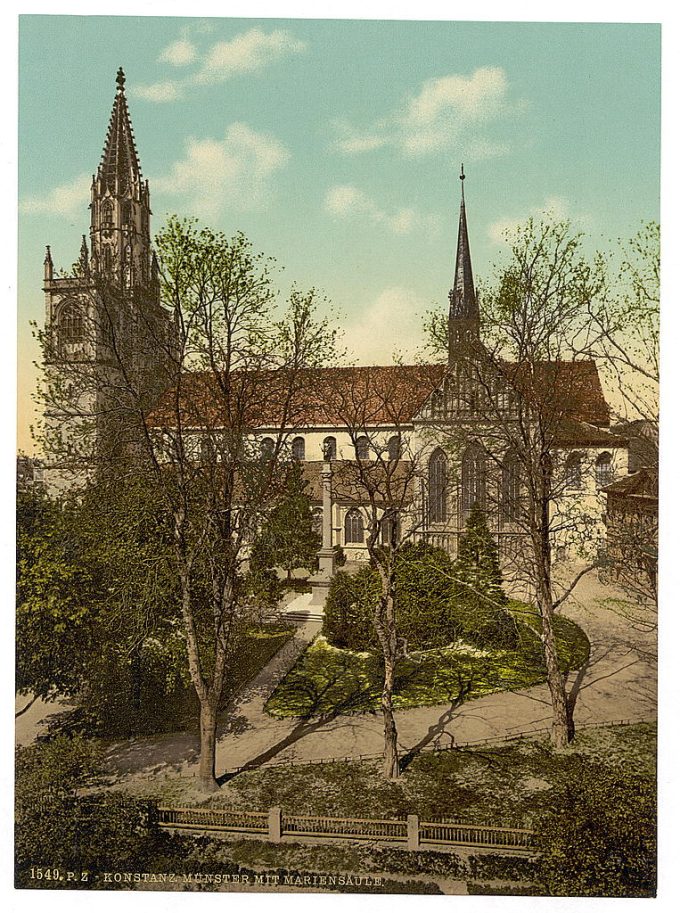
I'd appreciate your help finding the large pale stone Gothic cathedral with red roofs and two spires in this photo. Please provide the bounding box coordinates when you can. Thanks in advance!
[44,70,627,560]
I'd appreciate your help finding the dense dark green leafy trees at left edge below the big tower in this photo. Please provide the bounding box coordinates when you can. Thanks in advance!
[17,473,189,735]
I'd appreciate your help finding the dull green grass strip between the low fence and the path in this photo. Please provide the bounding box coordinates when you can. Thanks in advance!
[205,723,656,827]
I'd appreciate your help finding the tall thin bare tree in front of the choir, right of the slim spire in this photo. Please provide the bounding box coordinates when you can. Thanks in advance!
[429,221,617,747]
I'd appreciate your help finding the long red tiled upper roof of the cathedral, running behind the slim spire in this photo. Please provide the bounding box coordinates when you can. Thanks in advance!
[150,361,614,430]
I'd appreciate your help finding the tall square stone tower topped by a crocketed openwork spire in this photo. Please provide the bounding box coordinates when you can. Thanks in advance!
[43,69,172,489]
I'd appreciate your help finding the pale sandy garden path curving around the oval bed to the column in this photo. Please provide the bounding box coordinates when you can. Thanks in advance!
[18,575,656,785]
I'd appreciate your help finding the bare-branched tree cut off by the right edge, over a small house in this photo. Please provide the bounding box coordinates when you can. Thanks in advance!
[590,222,660,632]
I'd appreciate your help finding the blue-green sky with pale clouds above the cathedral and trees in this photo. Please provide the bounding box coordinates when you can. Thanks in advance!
[18,16,660,449]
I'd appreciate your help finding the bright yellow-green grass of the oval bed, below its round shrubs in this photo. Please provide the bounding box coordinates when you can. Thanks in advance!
[265,603,590,717]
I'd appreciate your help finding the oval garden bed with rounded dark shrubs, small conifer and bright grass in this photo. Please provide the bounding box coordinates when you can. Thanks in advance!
[266,510,590,717]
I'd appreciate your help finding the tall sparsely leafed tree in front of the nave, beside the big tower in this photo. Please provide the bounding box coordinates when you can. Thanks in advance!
[37,219,333,791]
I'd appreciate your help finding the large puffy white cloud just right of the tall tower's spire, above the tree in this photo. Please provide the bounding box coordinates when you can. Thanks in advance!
[153,123,290,219]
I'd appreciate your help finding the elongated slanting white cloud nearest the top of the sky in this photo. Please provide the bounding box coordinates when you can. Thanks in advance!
[194,28,306,84]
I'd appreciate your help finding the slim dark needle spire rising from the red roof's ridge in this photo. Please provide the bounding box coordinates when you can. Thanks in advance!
[449,165,479,366]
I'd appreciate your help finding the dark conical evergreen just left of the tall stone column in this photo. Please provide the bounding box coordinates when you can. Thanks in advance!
[251,462,321,581]
